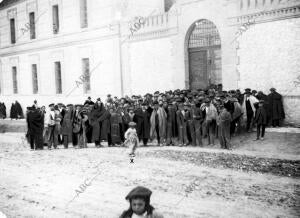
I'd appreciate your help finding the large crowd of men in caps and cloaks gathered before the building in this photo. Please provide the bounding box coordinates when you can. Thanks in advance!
[26,87,285,149]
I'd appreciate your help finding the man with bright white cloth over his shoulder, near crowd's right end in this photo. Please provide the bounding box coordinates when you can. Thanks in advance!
[242,88,258,132]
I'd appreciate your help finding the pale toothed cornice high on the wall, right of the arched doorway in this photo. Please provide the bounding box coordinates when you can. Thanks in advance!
[228,4,300,26]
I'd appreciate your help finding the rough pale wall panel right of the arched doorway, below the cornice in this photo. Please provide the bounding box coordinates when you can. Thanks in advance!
[237,18,300,124]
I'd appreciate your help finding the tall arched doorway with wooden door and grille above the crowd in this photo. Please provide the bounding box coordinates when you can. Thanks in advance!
[186,20,222,89]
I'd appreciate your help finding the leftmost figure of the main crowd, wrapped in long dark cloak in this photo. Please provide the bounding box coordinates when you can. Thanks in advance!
[27,107,44,150]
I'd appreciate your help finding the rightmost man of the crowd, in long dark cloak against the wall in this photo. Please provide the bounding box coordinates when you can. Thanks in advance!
[268,88,285,127]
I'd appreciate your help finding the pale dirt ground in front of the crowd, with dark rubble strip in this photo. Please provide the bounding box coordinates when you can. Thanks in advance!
[0,131,300,218]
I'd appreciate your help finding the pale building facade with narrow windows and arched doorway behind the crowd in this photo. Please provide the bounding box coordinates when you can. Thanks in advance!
[0,0,300,125]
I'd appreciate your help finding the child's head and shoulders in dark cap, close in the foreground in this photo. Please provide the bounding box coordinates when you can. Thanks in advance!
[120,186,163,218]
